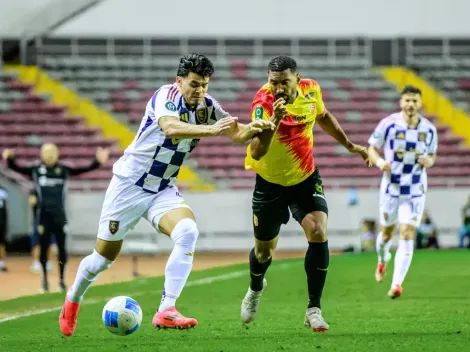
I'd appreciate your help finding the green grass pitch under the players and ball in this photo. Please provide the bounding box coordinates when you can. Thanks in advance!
[0,251,470,352]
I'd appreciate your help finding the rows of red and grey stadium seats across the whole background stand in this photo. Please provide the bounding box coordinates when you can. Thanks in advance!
[0,41,470,189]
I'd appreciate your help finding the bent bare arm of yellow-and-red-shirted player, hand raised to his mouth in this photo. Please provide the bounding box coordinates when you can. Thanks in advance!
[250,98,287,160]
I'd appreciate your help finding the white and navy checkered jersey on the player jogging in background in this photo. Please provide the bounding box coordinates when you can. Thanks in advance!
[369,112,437,198]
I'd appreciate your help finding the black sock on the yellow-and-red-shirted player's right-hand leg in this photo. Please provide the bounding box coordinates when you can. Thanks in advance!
[305,241,330,308]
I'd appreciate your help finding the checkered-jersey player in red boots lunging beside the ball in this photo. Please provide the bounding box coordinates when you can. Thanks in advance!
[59,54,275,336]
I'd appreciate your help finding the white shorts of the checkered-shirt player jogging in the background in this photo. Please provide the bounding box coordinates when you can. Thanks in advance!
[380,194,426,227]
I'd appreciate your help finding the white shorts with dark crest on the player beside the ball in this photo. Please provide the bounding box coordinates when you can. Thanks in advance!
[98,175,191,241]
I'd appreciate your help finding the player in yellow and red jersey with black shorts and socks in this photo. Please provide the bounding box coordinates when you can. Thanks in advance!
[241,56,371,331]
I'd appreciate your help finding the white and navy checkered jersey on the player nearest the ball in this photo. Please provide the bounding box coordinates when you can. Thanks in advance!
[113,84,230,193]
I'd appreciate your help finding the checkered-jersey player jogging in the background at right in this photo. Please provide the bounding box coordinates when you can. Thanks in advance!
[369,86,437,298]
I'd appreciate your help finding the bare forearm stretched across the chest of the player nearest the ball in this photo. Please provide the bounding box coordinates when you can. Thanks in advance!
[158,116,238,139]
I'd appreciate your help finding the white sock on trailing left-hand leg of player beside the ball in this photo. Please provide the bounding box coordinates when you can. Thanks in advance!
[67,250,114,303]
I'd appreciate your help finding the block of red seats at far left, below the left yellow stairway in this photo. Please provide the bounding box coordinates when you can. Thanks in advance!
[0,72,120,191]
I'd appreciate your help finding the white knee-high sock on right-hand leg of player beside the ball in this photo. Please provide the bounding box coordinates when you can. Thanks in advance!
[158,219,199,312]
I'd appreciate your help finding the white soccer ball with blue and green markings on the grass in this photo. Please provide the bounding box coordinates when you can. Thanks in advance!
[102,296,142,336]
